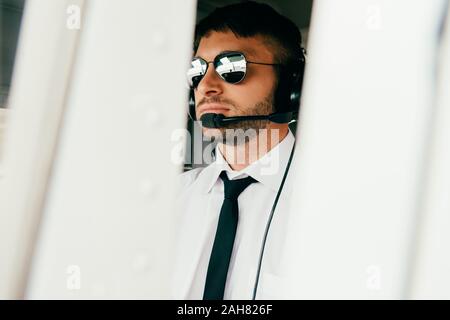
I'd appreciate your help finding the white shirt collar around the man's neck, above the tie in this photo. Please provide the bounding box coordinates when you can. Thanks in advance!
[203,130,295,193]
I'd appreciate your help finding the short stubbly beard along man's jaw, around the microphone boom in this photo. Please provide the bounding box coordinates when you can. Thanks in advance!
[203,93,274,146]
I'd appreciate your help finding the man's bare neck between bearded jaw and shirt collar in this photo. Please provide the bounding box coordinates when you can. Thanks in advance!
[219,124,289,171]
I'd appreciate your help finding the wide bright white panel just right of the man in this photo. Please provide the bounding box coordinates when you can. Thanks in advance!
[286,0,444,299]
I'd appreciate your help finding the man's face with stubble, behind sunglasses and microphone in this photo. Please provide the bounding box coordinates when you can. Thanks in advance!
[194,31,276,144]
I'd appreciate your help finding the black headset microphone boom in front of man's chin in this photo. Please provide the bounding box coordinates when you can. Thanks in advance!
[200,111,296,128]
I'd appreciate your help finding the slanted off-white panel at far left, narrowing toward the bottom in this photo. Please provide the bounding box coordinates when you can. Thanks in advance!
[0,0,83,298]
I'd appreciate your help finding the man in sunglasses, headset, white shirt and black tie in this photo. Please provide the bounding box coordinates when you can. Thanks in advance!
[174,1,304,299]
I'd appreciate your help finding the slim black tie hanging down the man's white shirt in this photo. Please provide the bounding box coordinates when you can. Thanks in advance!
[203,171,256,300]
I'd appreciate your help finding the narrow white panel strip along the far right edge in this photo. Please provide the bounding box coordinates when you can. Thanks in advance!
[412,7,450,299]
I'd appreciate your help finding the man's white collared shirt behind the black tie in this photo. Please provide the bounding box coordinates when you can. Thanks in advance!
[173,131,295,299]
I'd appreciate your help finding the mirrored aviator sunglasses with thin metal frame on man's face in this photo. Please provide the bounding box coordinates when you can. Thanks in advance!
[187,51,279,89]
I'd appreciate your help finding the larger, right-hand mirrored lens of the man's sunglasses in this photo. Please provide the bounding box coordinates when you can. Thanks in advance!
[214,52,247,83]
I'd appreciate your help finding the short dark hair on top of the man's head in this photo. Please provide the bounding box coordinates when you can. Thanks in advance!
[194,1,302,65]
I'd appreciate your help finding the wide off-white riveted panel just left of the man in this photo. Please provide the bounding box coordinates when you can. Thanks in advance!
[28,0,195,298]
